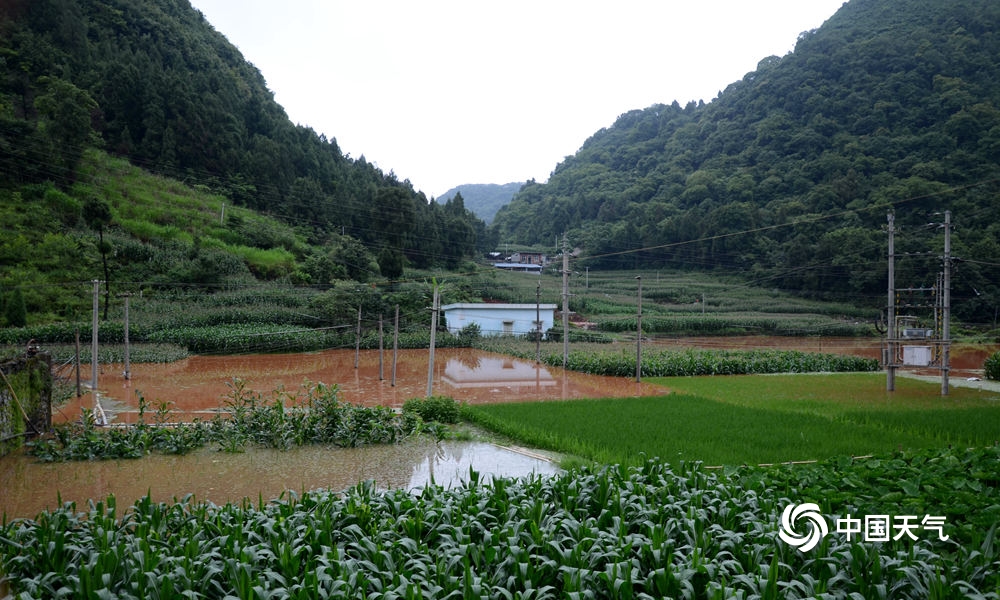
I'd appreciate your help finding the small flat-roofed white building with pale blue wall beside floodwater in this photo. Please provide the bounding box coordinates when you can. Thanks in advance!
[441,304,556,336]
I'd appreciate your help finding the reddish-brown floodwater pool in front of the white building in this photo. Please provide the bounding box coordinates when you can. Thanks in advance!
[53,348,667,423]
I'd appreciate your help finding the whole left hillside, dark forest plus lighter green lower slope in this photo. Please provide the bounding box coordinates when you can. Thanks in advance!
[0,0,485,324]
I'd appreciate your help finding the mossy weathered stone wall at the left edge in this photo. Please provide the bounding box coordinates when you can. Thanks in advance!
[0,352,52,456]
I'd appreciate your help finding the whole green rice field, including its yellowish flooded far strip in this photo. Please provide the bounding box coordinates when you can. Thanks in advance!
[464,374,1000,465]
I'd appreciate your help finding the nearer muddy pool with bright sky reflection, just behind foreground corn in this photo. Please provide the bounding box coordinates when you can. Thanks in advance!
[0,440,559,519]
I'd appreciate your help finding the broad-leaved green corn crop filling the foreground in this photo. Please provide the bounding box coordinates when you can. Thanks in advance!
[0,448,1000,599]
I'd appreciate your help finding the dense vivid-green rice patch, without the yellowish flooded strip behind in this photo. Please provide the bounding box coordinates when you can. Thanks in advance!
[463,394,948,465]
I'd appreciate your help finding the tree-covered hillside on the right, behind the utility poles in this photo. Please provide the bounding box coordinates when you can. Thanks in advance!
[493,0,1000,323]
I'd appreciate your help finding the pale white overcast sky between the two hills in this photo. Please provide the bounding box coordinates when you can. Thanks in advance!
[191,0,844,197]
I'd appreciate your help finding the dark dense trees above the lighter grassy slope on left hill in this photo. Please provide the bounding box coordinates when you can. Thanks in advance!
[0,0,485,296]
